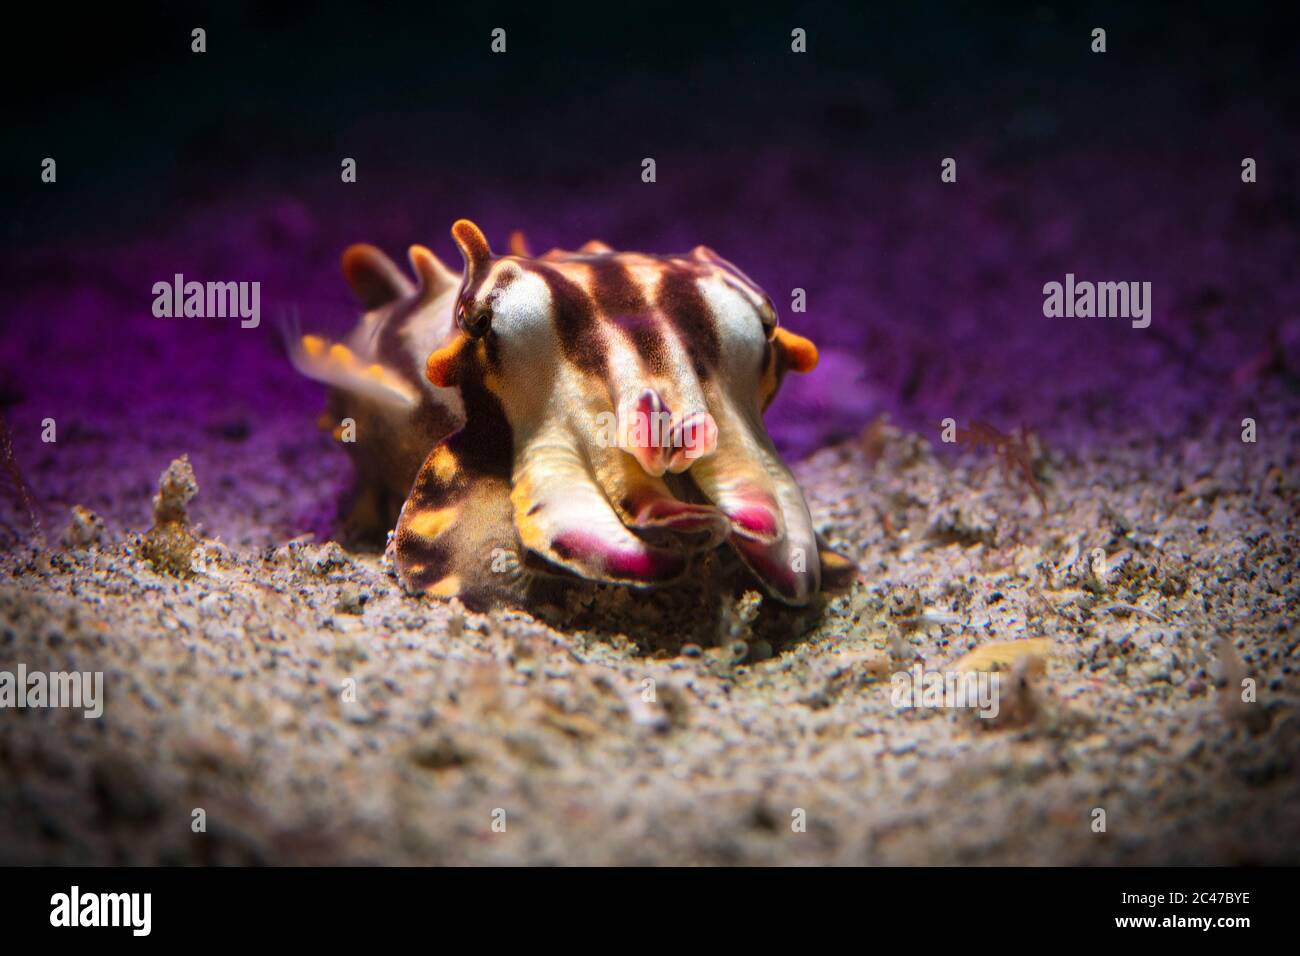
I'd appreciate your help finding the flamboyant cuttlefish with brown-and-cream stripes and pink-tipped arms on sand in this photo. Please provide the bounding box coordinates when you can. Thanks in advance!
[293,220,853,607]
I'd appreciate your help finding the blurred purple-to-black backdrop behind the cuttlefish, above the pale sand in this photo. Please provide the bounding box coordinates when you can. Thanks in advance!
[0,4,1300,540]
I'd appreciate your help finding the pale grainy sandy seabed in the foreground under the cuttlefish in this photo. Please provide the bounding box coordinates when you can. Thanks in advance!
[0,395,1300,864]
